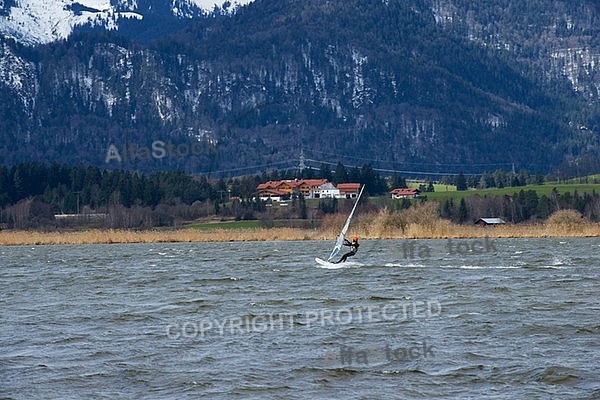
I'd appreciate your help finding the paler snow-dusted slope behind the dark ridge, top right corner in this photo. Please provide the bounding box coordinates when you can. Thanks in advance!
[430,0,600,102]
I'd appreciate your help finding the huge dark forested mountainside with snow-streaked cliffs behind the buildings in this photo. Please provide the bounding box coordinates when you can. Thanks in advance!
[0,0,600,175]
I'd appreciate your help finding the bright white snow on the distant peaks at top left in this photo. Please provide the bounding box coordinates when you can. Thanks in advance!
[0,0,252,45]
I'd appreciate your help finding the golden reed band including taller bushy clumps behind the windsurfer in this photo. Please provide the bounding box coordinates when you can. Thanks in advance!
[0,208,600,246]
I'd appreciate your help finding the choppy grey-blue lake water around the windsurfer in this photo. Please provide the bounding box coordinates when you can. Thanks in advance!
[0,238,600,399]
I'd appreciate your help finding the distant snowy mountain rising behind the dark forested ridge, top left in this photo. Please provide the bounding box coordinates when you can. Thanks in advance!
[0,0,250,45]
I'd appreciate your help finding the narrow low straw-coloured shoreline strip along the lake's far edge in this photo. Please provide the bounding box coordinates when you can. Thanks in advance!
[0,223,600,246]
